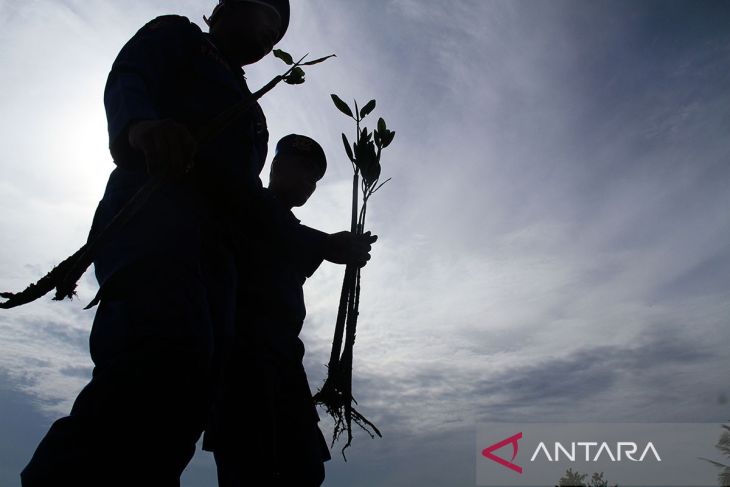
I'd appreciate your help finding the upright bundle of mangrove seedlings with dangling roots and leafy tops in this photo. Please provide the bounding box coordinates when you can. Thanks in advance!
[314,95,395,461]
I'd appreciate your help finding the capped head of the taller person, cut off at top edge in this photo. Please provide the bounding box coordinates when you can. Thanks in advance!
[205,0,289,66]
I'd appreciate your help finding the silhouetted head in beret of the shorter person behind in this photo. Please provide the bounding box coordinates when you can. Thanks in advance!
[269,134,327,209]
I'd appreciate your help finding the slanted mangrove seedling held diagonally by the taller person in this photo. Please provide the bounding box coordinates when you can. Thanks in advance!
[0,49,334,309]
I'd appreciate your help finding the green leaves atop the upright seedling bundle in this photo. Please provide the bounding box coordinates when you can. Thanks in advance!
[331,94,395,187]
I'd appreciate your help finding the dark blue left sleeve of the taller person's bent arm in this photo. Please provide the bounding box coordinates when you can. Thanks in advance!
[104,15,196,170]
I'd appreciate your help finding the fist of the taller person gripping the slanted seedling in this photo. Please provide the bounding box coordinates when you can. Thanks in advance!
[128,118,197,176]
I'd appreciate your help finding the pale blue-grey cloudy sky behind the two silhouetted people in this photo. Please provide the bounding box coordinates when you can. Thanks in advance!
[0,0,730,487]
